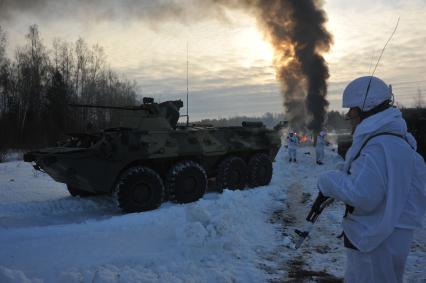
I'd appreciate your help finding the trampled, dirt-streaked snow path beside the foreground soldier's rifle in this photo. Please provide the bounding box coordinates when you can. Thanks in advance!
[264,148,343,282]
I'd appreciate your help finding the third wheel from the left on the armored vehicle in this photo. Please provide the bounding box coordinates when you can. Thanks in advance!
[216,156,248,192]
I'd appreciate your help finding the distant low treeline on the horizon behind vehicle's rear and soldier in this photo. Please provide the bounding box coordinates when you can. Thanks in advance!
[196,111,350,131]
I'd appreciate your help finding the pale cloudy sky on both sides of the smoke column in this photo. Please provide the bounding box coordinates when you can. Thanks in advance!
[0,0,426,120]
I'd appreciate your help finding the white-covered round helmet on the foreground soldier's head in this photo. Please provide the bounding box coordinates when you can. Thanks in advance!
[342,76,392,112]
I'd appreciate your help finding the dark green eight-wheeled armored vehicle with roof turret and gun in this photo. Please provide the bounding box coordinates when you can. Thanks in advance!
[24,98,281,212]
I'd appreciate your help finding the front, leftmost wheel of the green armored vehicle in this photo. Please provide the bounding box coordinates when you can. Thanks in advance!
[114,166,164,212]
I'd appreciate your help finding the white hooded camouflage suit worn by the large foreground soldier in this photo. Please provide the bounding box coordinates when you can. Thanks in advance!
[318,108,426,283]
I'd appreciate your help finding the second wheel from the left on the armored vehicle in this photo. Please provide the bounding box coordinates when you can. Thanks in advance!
[166,161,207,203]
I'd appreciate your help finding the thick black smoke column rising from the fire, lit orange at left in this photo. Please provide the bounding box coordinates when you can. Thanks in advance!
[230,0,332,132]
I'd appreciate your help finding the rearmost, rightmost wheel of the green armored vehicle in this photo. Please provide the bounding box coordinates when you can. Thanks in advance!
[248,153,272,188]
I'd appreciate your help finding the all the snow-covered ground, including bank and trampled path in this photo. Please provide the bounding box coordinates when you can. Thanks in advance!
[0,147,426,283]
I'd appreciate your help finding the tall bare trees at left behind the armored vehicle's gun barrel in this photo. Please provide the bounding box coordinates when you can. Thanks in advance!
[0,25,138,149]
